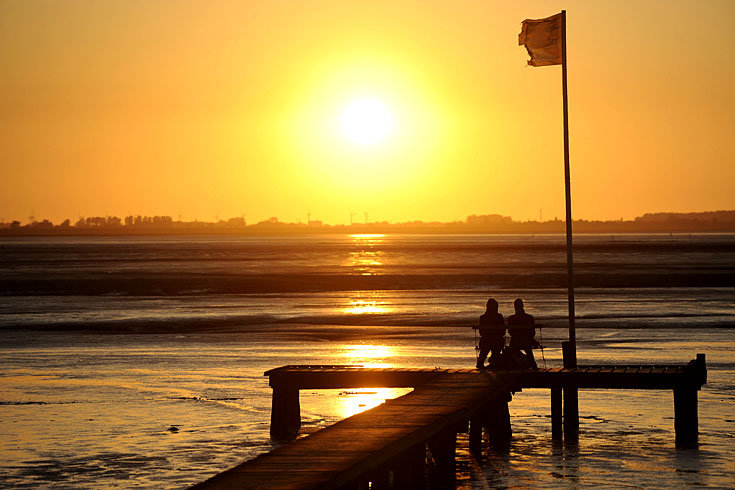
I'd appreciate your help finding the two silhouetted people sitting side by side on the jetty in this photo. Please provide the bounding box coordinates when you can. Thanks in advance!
[476,298,539,369]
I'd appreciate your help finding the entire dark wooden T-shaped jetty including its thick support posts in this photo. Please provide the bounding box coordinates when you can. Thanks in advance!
[196,354,707,489]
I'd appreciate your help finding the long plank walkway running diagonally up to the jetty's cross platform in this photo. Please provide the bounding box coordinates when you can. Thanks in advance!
[194,371,513,490]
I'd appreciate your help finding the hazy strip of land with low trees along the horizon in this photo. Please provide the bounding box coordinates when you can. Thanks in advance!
[0,211,735,234]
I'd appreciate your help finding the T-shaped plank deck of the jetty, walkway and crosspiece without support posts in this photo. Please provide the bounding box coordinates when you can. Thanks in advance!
[221,365,706,489]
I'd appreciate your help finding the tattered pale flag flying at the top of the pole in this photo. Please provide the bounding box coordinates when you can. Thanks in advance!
[518,14,562,66]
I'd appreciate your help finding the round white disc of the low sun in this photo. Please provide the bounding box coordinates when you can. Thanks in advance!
[339,98,393,146]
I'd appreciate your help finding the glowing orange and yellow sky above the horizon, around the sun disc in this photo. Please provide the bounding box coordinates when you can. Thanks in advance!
[0,0,735,223]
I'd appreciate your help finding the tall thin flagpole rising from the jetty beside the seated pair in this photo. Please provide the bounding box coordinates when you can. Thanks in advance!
[561,10,577,367]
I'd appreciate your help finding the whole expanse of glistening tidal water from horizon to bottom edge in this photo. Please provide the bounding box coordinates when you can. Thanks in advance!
[0,235,735,488]
